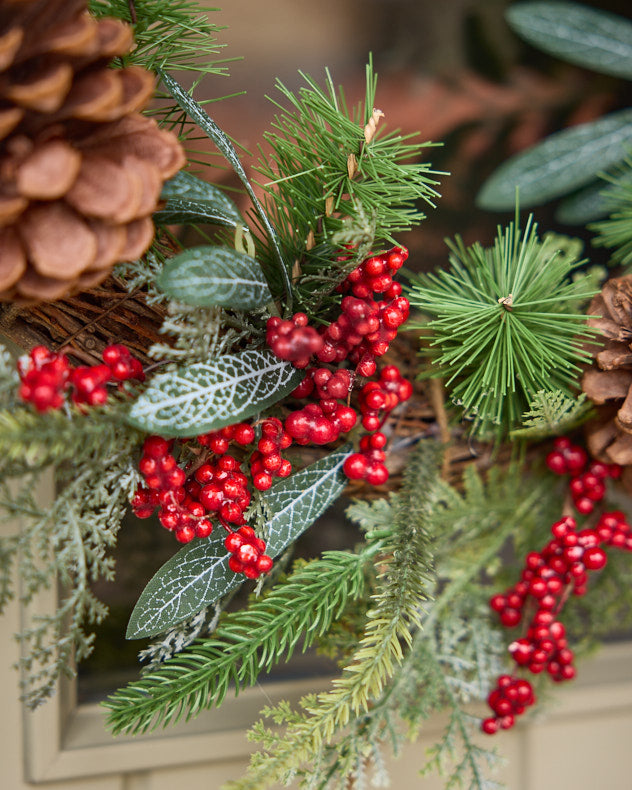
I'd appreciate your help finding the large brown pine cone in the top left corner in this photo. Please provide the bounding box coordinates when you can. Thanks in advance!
[0,0,184,302]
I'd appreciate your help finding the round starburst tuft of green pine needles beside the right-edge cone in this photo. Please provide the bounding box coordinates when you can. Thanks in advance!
[410,216,594,437]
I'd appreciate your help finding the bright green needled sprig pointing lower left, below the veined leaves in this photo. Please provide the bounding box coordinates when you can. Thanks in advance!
[104,546,372,733]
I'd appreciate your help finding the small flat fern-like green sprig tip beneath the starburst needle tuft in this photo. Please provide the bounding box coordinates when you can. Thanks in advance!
[510,390,592,440]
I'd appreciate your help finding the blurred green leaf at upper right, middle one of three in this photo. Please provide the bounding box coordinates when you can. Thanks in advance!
[477,109,632,211]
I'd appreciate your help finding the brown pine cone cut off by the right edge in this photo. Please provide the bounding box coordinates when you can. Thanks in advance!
[582,275,632,466]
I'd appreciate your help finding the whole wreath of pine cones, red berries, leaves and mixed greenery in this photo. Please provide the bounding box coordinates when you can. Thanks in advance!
[0,0,632,790]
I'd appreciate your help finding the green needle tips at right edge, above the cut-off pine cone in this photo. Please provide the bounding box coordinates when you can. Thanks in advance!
[589,157,632,266]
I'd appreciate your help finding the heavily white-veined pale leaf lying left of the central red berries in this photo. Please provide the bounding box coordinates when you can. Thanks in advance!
[128,350,304,437]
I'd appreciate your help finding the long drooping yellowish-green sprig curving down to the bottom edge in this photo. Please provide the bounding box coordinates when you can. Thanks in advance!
[229,442,441,790]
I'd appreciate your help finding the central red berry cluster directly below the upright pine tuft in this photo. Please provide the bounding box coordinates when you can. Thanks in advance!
[267,247,412,485]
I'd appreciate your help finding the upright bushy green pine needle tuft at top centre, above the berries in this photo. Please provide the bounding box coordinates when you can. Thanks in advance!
[258,63,438,312]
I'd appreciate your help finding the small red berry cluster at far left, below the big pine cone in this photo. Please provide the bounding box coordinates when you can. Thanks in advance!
[18,345,145,412]
